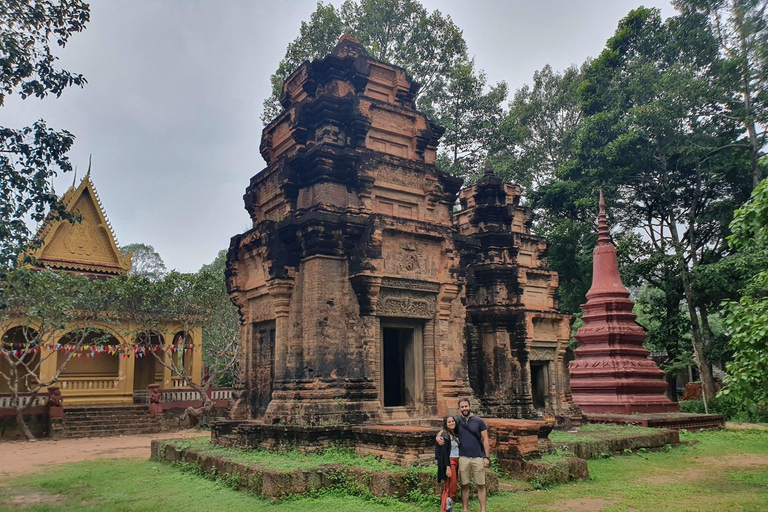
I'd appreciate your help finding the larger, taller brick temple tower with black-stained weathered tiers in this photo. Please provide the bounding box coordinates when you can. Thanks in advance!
[229,35,470,423]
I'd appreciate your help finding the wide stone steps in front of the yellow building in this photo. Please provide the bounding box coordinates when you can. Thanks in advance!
[54,405,162,438]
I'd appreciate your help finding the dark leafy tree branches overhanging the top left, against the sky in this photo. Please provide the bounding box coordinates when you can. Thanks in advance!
[0,0,90,267]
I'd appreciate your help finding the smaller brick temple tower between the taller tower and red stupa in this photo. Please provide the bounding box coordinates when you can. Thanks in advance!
[454,167,581,420]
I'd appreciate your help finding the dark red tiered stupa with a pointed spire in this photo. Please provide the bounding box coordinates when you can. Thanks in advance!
[569,191,678,414]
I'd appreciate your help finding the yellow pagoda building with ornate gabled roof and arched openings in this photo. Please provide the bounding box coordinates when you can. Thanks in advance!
[0,174,202,405]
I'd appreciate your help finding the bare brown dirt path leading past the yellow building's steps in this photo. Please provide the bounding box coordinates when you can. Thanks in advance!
[0,430,211,480]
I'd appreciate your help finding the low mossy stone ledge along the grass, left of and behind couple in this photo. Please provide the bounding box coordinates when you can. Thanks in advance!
[151,440,499,499]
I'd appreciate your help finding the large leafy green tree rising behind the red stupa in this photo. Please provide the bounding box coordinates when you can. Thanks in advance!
[532,8,750,392]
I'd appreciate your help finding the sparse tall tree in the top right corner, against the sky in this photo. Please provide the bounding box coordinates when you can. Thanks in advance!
[672,0,768,187]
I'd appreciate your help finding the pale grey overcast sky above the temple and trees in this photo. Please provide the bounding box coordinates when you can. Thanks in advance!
[0,0,674,272]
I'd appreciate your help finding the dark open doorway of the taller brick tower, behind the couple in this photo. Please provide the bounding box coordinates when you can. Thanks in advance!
[381,322,424,407]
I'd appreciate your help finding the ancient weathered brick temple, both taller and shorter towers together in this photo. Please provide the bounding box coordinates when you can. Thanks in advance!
[227,35,579,424]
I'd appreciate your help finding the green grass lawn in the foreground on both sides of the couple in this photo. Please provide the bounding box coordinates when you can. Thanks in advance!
[0,430,768,512]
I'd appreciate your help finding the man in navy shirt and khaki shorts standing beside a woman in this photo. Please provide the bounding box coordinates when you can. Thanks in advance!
[436,398,491,512]
